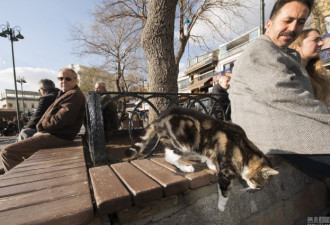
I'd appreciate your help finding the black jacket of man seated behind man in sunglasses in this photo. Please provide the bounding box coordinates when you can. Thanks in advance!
[27,88,59,129]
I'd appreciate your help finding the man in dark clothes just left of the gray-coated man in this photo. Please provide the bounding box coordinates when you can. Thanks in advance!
[212,75,231,121]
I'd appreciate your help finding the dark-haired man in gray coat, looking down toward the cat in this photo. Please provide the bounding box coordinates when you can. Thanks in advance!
[229,0,330,175]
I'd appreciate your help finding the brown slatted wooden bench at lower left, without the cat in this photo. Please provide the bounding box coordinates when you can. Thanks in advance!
[0,140,94,225]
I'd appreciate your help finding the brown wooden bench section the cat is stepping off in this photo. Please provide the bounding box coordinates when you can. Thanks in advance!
[89,157,217,216]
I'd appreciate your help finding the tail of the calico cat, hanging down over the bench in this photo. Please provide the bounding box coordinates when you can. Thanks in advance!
[130,124,156,160]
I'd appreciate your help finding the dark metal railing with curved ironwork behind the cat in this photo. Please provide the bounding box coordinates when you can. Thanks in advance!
[85,92,228,166]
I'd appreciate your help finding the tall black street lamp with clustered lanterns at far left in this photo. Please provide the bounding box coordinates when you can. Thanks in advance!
[0,22,24,131]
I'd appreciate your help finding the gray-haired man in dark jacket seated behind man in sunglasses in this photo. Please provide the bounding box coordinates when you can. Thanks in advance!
[17,79,60,141]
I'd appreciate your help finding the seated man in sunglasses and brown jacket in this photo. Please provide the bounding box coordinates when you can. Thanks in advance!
[0,68,85,172]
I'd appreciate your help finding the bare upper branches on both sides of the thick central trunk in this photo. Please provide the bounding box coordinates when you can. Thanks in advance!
[91,0,249,68]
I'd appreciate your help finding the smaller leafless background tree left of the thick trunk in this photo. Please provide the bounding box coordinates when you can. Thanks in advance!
[72,4,146,91]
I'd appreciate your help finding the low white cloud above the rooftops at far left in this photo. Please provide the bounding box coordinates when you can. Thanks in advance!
[0,67,57,92]
